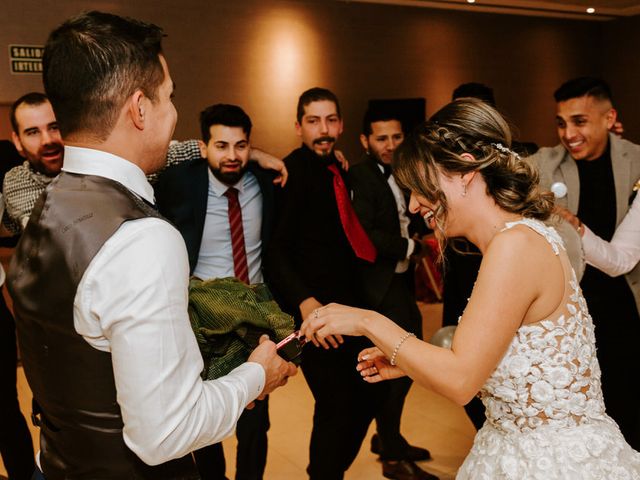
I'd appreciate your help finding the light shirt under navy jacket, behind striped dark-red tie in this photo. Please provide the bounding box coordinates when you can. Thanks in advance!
[193,170,263,283]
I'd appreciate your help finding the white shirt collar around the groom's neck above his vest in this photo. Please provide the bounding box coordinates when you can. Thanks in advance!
[62,145,155,203]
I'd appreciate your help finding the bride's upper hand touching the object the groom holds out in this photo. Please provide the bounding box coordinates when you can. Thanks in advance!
[300,303,378,348]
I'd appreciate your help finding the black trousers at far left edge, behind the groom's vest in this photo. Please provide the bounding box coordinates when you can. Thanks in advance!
[0,288,35,480]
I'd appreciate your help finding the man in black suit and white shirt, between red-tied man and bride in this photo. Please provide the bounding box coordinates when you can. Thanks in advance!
[349,109,435,480]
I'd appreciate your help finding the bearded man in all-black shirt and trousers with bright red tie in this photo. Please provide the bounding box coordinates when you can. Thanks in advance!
[266,88,387,480]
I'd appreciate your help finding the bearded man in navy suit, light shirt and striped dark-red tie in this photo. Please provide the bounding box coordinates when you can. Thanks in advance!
[155,104,275,480]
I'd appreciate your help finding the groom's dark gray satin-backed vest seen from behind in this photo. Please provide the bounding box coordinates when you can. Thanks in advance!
[7,172,199,480]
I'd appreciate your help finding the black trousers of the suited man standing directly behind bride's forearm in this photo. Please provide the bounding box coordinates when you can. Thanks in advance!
[376,269,422,460]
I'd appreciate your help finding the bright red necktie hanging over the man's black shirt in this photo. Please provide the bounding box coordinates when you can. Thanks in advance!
[329,163,377,263]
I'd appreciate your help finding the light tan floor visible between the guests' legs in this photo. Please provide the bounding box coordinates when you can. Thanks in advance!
[0,304,475,480]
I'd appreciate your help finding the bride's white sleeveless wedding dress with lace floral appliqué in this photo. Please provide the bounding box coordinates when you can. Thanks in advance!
[456,219,640,480]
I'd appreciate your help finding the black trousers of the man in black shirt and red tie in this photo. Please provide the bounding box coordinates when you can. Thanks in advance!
[302,337,388,480]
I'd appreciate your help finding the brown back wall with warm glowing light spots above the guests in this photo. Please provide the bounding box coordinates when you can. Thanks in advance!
[0,0,604,157]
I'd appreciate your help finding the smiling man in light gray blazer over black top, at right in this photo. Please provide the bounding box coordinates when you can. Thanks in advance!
[531,77,640,450]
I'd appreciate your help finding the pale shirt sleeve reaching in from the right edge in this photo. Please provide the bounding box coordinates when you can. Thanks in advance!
[582,195,640,277]
